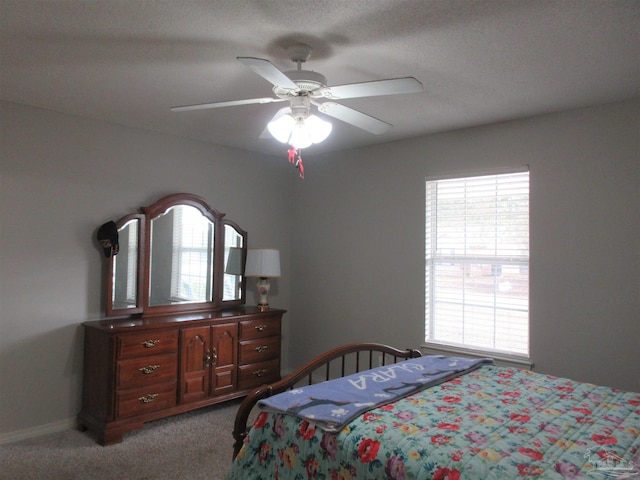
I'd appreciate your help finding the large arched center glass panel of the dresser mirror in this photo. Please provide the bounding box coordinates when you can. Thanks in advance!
[149,205,214,306]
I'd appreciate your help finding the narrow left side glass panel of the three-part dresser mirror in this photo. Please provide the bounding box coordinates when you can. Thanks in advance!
[111,220,139,310]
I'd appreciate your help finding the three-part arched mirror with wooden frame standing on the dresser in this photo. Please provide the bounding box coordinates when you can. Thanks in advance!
[106,193,247,316]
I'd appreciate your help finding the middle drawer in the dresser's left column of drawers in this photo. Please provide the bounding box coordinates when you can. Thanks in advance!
[116,353,178,389]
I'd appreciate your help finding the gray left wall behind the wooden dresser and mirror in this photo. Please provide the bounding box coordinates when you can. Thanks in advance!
[0,103,296,435]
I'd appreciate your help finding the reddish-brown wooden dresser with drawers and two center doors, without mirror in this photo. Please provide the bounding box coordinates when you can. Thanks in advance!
[78,306,285,445]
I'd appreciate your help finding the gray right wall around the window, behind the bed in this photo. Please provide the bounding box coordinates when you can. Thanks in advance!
[290,101,640,391]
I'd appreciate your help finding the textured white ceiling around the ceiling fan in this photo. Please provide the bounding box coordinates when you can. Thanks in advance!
[0,0,640,156]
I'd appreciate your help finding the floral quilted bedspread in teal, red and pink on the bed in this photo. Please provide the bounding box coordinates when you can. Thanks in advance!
[228,365,640,480]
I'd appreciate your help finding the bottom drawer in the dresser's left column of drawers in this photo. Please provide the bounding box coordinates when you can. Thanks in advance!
[116,382,176,419]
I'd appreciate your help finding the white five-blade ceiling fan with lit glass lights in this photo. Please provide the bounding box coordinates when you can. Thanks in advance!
[171,43,423,150]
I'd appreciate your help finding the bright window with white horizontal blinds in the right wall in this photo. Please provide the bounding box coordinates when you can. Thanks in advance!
[425,171,529,356]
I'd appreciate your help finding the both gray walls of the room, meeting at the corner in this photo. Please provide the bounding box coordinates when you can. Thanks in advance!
[0,101,640,439]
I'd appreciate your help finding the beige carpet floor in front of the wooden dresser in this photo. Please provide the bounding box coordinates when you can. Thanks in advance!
[0,401,250,480]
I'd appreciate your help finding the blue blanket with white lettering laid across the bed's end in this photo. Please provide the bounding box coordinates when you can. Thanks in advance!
[258,355,493,432]
